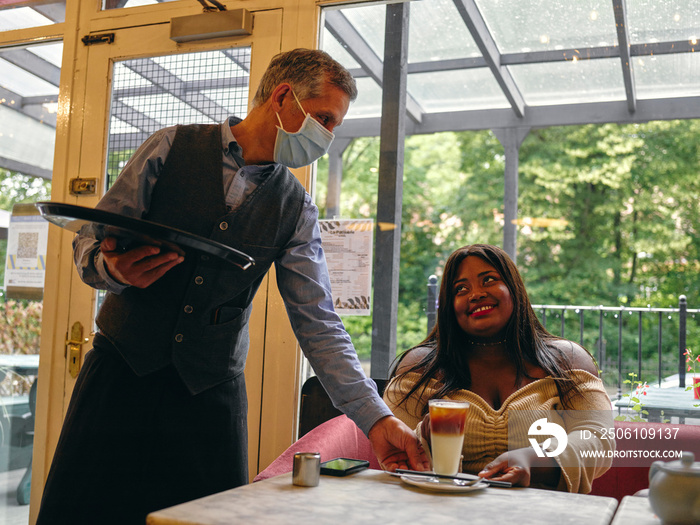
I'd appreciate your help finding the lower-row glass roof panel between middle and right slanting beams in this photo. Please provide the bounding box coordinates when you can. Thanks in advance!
[508,58,625,106]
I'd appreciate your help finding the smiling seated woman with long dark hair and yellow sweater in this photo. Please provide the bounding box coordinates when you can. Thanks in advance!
[384,244,614,493]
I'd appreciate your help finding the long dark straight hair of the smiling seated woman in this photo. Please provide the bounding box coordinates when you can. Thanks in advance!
[394,244,579,407]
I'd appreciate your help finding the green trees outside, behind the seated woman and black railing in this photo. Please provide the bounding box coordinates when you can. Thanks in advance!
[316,120,700,383]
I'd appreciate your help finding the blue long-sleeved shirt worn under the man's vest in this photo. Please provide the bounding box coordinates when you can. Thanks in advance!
[73,117,391,434]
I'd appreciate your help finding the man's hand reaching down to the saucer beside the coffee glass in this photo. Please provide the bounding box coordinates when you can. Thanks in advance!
[368,416,430,472]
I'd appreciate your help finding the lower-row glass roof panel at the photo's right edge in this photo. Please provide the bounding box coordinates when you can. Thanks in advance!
[632,53,700,99]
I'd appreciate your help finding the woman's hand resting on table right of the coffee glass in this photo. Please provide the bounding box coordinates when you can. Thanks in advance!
[479,448,560,487]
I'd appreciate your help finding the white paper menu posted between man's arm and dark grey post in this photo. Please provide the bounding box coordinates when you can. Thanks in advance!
[319,219,374,315]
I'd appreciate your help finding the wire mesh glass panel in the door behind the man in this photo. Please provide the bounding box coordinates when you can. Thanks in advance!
[107,47,250,188]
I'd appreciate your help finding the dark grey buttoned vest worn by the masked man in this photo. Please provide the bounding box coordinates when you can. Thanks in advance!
[97,125,305,393]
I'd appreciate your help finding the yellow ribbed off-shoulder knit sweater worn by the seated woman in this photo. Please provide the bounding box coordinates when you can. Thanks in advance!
[384,370,615,494]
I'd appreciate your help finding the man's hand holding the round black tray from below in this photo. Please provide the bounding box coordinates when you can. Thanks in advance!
[100,237,185,288]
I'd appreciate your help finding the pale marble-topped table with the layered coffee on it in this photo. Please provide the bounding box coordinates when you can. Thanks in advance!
[147,470,617,525]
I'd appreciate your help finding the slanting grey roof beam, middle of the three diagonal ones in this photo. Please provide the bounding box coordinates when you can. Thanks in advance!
[454,0,525,118]
